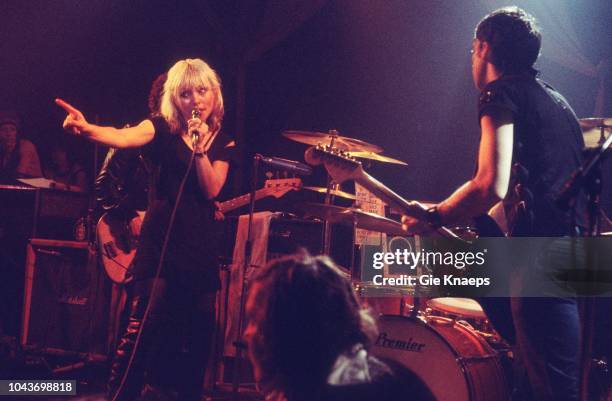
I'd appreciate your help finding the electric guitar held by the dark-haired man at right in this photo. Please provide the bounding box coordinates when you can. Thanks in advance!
[304,145,504,236]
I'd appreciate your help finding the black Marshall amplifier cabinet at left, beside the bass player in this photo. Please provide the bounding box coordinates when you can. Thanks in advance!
[21,239,110,356]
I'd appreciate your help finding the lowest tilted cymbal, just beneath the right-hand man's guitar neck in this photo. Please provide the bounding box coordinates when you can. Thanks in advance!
[300,203,408,236]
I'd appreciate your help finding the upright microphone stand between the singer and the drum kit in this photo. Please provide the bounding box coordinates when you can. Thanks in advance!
[232,154,262,401]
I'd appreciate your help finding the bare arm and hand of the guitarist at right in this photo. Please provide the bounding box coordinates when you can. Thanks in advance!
[402,109,514,232]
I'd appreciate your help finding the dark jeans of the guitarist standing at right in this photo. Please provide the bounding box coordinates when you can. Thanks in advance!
[512,237,586,401]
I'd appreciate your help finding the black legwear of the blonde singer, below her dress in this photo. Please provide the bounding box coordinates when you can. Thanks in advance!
[109,279,215,401]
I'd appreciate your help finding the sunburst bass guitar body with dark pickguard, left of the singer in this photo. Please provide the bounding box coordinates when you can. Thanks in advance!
[96,212,144,284]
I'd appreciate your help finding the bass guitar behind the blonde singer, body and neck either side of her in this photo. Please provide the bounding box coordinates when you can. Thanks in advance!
[96,178,302,284]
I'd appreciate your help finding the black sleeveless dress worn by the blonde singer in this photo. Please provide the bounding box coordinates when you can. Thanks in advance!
[133,117,235,292]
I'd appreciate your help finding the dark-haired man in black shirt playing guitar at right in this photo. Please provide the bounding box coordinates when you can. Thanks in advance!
[402,7,586,401]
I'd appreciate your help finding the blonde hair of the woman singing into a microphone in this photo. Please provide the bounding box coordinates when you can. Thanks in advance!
[160,58,224,134]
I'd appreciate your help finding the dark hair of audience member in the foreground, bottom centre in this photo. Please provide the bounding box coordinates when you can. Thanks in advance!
[250,251,376,401]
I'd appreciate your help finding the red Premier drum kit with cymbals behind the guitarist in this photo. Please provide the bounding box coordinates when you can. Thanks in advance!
[283,118,612,401]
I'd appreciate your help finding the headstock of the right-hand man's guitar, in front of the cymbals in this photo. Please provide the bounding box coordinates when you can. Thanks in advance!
[304,145,364,184]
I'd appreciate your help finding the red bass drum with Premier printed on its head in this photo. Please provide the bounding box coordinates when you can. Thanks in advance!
[372,316,510,401]
